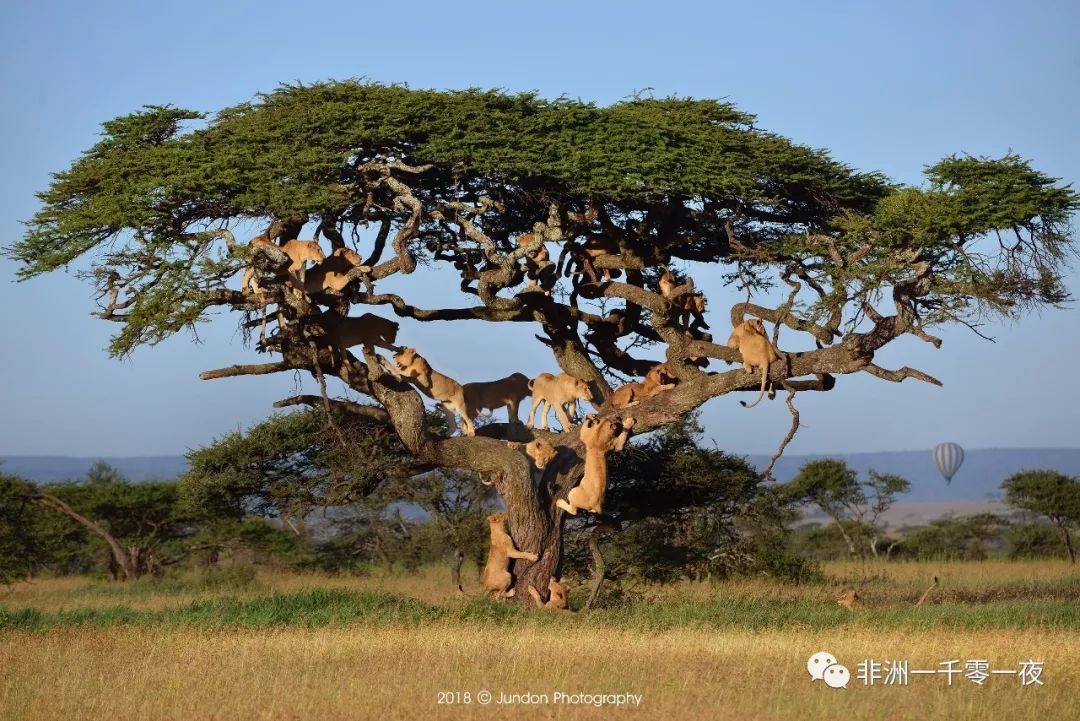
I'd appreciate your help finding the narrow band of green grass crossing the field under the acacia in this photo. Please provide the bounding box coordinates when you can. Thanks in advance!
[0,588,1080,631]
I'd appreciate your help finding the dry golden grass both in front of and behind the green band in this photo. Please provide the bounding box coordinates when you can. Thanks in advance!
[0,562,1080,721]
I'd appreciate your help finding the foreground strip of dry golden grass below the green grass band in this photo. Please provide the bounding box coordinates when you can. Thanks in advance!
[0,624,1080,721]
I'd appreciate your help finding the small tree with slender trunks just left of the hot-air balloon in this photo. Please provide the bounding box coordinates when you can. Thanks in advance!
[787,459,910,558]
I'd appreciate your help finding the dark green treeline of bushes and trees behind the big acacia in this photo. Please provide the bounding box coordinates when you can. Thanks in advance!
[0,410,1080,593]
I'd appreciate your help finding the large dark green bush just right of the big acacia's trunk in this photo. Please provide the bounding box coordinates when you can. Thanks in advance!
[568,416,814,583]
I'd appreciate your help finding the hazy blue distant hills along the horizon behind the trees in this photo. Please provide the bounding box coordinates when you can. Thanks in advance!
[0,448,1080,504]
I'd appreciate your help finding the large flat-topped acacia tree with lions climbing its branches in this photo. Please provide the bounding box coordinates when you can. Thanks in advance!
[8,81,1078,598]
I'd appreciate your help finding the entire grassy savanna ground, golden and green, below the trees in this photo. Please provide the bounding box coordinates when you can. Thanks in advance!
[0,561,1080,721]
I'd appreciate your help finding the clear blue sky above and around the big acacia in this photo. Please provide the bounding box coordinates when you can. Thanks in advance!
[0,0,1080,455]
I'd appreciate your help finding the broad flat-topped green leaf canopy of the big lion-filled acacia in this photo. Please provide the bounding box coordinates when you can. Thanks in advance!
[8,81,1080,355]
